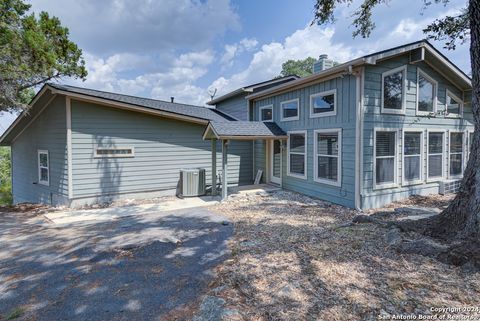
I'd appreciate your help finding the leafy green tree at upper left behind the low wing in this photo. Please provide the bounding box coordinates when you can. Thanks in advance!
[0,0,87,111]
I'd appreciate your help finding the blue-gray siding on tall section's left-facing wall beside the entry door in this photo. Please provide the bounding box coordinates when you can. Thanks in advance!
[254,76,356,207]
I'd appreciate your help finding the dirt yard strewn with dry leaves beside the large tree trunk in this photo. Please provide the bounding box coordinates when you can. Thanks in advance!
[211,191,480,321]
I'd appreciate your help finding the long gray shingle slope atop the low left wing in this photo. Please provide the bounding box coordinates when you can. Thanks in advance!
[48,83,235,122]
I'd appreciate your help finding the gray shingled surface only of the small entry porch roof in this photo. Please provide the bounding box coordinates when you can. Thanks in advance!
[210,121,287,137]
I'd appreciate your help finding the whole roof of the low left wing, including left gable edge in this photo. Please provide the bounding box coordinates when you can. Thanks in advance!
[0,84,236,145]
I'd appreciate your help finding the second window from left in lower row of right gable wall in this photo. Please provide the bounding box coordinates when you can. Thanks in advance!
[403,132,423,183]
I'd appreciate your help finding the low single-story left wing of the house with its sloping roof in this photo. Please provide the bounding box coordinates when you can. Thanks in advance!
[0,84,268,207]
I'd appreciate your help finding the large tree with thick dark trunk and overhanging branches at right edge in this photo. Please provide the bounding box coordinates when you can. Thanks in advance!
[312,0,480,241]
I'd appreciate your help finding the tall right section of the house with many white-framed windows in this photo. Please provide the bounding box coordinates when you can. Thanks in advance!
[228,40,474,209]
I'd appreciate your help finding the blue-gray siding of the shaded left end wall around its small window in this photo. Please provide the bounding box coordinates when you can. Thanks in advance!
[12,95,68,204]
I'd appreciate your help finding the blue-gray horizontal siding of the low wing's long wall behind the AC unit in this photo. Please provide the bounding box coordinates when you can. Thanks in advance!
[72,100,253,199]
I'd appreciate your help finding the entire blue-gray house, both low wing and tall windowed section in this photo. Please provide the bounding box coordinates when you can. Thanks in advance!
[0,40,473,209]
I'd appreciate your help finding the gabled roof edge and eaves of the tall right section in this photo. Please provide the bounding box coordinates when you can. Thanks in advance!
[246,40,472,100]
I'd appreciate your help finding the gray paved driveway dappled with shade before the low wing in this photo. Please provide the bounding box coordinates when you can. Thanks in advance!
[0,208,232,320]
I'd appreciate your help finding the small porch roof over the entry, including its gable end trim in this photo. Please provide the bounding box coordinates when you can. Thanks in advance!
[203,121,287,139]
